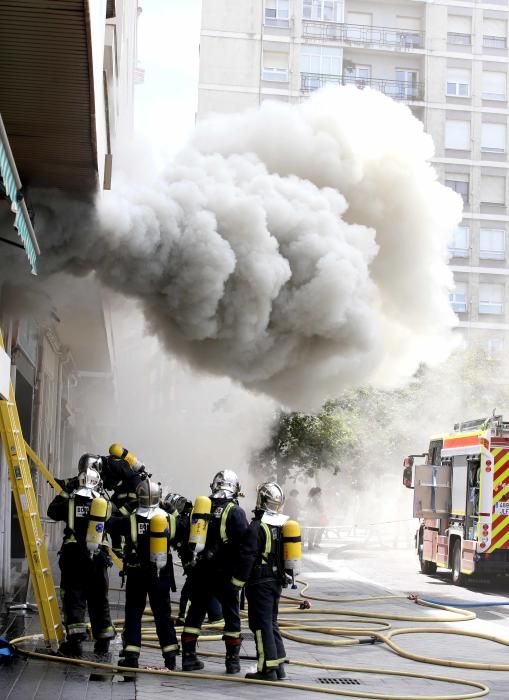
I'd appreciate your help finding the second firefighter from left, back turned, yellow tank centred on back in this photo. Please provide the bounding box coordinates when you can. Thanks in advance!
[109,479,178,671]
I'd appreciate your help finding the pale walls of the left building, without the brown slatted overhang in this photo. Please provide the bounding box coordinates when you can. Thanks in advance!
[0,0,138,594]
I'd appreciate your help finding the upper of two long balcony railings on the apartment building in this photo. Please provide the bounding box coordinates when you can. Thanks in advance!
[302,20,424,49]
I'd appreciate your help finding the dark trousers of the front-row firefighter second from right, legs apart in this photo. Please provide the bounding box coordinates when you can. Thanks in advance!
[183,564,240,642]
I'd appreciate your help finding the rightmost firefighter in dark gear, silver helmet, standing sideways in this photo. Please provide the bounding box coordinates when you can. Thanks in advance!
[233,482,288,681]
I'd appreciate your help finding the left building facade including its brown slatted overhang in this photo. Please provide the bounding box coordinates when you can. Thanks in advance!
[0,0,139,595]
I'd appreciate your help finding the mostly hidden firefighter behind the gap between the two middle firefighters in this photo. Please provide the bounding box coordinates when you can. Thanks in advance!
[161,493,224,625]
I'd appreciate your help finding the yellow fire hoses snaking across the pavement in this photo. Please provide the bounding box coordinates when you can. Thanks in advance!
[11,580,509,700]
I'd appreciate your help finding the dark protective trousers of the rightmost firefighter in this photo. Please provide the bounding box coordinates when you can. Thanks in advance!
[246,579,286,672]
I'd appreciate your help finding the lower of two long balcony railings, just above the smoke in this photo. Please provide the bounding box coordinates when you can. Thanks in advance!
[300,73,424,102]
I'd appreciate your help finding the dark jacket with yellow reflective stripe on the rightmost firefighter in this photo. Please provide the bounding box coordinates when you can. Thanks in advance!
[232,510,288,587]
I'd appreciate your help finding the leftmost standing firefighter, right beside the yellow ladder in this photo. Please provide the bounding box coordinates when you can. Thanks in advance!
[48,456,115,656]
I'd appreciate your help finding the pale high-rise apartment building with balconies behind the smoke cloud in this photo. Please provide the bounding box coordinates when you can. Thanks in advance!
[198,0,509,357]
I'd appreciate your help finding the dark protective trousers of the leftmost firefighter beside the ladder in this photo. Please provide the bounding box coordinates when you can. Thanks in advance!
[58,542,115,640]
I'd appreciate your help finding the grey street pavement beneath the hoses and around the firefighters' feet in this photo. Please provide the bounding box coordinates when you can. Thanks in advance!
[0,531,509,700]
